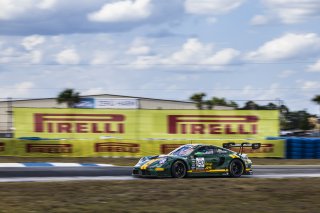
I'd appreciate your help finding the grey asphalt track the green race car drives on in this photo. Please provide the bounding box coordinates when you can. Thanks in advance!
[0,165,320,182]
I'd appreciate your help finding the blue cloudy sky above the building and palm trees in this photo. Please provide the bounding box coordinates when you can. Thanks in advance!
[0,0,320,113]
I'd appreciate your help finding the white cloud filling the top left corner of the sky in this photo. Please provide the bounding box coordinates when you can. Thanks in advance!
[0,0,56,20]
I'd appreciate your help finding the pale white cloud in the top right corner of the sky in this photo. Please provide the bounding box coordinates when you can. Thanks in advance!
[255,0,320,24]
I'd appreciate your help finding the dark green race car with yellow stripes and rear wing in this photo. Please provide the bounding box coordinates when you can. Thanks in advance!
[132,142,261,178]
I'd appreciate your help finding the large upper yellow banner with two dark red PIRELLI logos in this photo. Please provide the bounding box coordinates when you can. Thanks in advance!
[14,108,279,140]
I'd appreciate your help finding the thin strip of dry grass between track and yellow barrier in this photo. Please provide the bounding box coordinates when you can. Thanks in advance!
[0,157,320,166]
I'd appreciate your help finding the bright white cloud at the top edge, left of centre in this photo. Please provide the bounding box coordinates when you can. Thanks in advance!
[88,0,152,22]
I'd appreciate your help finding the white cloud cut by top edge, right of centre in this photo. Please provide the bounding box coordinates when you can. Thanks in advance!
[184,0,245,15]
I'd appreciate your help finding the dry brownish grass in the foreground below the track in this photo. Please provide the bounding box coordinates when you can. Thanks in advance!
[0,178,320,213]
